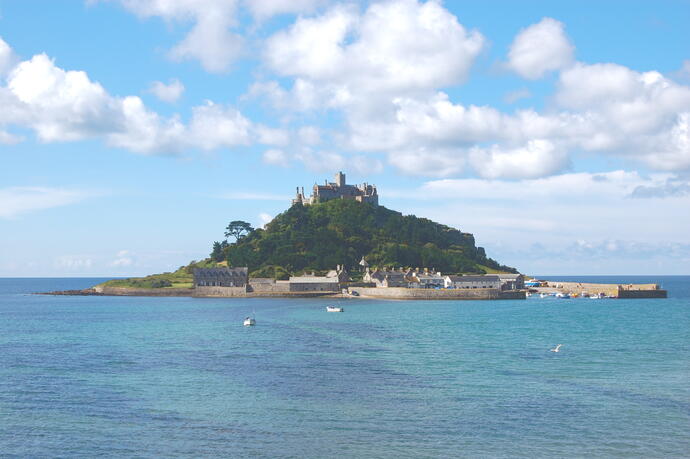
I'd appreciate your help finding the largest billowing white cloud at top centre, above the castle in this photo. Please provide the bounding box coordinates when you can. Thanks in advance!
[265,0,484,94]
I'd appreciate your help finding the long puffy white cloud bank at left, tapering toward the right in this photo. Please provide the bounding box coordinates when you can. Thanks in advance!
[0,50,255,154]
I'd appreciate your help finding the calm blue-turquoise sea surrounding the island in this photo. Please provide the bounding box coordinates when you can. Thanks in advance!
[0,276,690,459]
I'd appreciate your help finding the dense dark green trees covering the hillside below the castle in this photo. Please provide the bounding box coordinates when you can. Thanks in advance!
[227,200,516,277]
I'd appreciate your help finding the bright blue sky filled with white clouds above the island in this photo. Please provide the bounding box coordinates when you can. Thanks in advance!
[0,0,690,277]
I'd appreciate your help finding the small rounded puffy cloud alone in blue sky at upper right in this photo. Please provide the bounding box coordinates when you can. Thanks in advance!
[508,18,575,80]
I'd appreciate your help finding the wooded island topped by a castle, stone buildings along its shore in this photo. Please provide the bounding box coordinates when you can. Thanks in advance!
[51,172,665,300]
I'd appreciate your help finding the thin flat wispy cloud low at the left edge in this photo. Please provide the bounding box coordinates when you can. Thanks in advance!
[0,187,94,218]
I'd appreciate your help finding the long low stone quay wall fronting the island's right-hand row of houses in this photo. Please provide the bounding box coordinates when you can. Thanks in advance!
[350,287,525,300]
